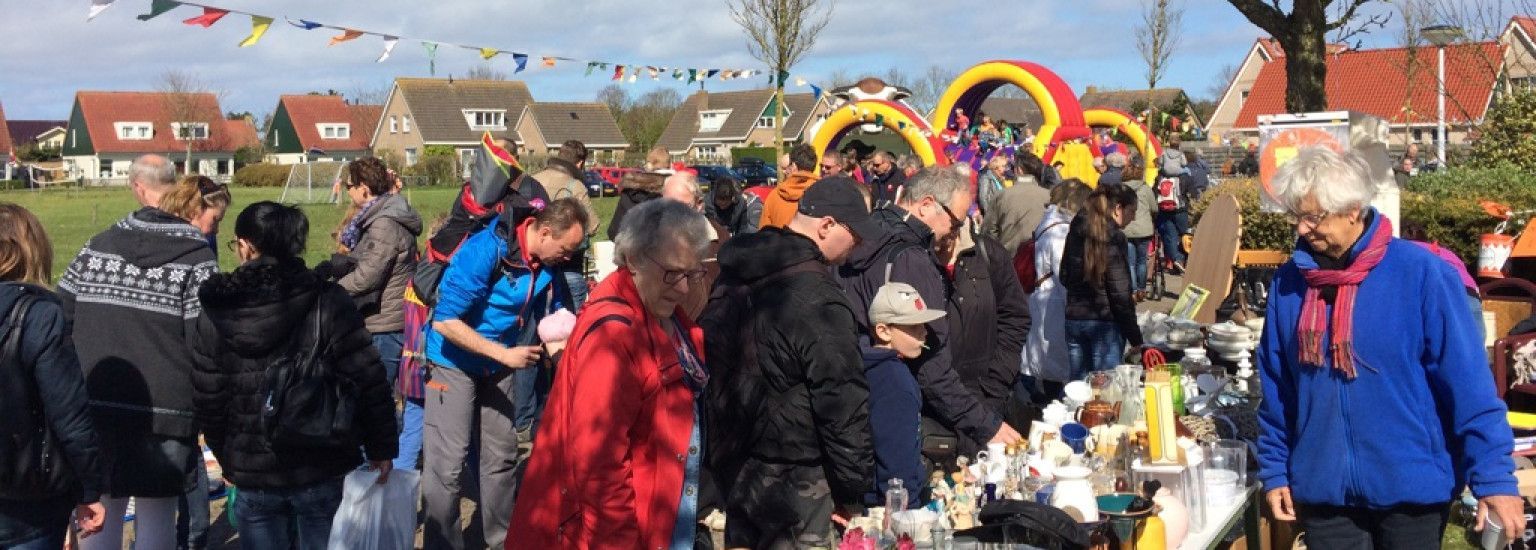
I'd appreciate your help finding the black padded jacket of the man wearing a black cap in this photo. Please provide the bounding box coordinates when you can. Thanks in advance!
[699,227,874,510]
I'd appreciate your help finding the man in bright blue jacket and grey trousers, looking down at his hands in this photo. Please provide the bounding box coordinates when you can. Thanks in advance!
[421,198,593,550]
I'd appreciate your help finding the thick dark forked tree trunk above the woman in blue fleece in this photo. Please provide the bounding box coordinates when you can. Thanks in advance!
[1227,0,1387,112]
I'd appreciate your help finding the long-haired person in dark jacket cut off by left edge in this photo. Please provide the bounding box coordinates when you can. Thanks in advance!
[0,203,106,550]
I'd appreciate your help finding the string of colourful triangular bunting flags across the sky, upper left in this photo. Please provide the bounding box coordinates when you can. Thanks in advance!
[102,0,761,83]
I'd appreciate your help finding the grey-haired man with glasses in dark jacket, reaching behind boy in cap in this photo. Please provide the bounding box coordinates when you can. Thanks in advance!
[839,167,1020,467]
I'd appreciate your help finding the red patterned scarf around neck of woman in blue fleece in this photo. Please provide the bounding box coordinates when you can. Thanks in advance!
[1296,215,1392,379]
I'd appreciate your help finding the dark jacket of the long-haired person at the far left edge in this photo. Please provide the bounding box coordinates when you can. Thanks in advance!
[0,283,104,547]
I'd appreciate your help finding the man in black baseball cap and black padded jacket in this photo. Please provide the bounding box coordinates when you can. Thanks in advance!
[699,178,880,548]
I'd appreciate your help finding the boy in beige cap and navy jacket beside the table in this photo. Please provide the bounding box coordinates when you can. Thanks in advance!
[863,283,945,507]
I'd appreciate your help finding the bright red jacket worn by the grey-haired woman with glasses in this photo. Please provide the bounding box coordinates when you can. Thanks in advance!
[507,269,703,550]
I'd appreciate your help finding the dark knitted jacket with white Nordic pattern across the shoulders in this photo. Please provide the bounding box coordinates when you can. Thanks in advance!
[58,207,218,442]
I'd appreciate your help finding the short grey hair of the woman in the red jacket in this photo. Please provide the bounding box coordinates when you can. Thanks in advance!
[613,200,710,267]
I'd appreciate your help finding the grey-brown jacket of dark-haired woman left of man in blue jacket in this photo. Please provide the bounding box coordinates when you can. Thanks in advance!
[336,194,421,333]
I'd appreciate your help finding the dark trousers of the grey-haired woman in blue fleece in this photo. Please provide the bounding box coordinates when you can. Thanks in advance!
[1296,504,1450,550]
